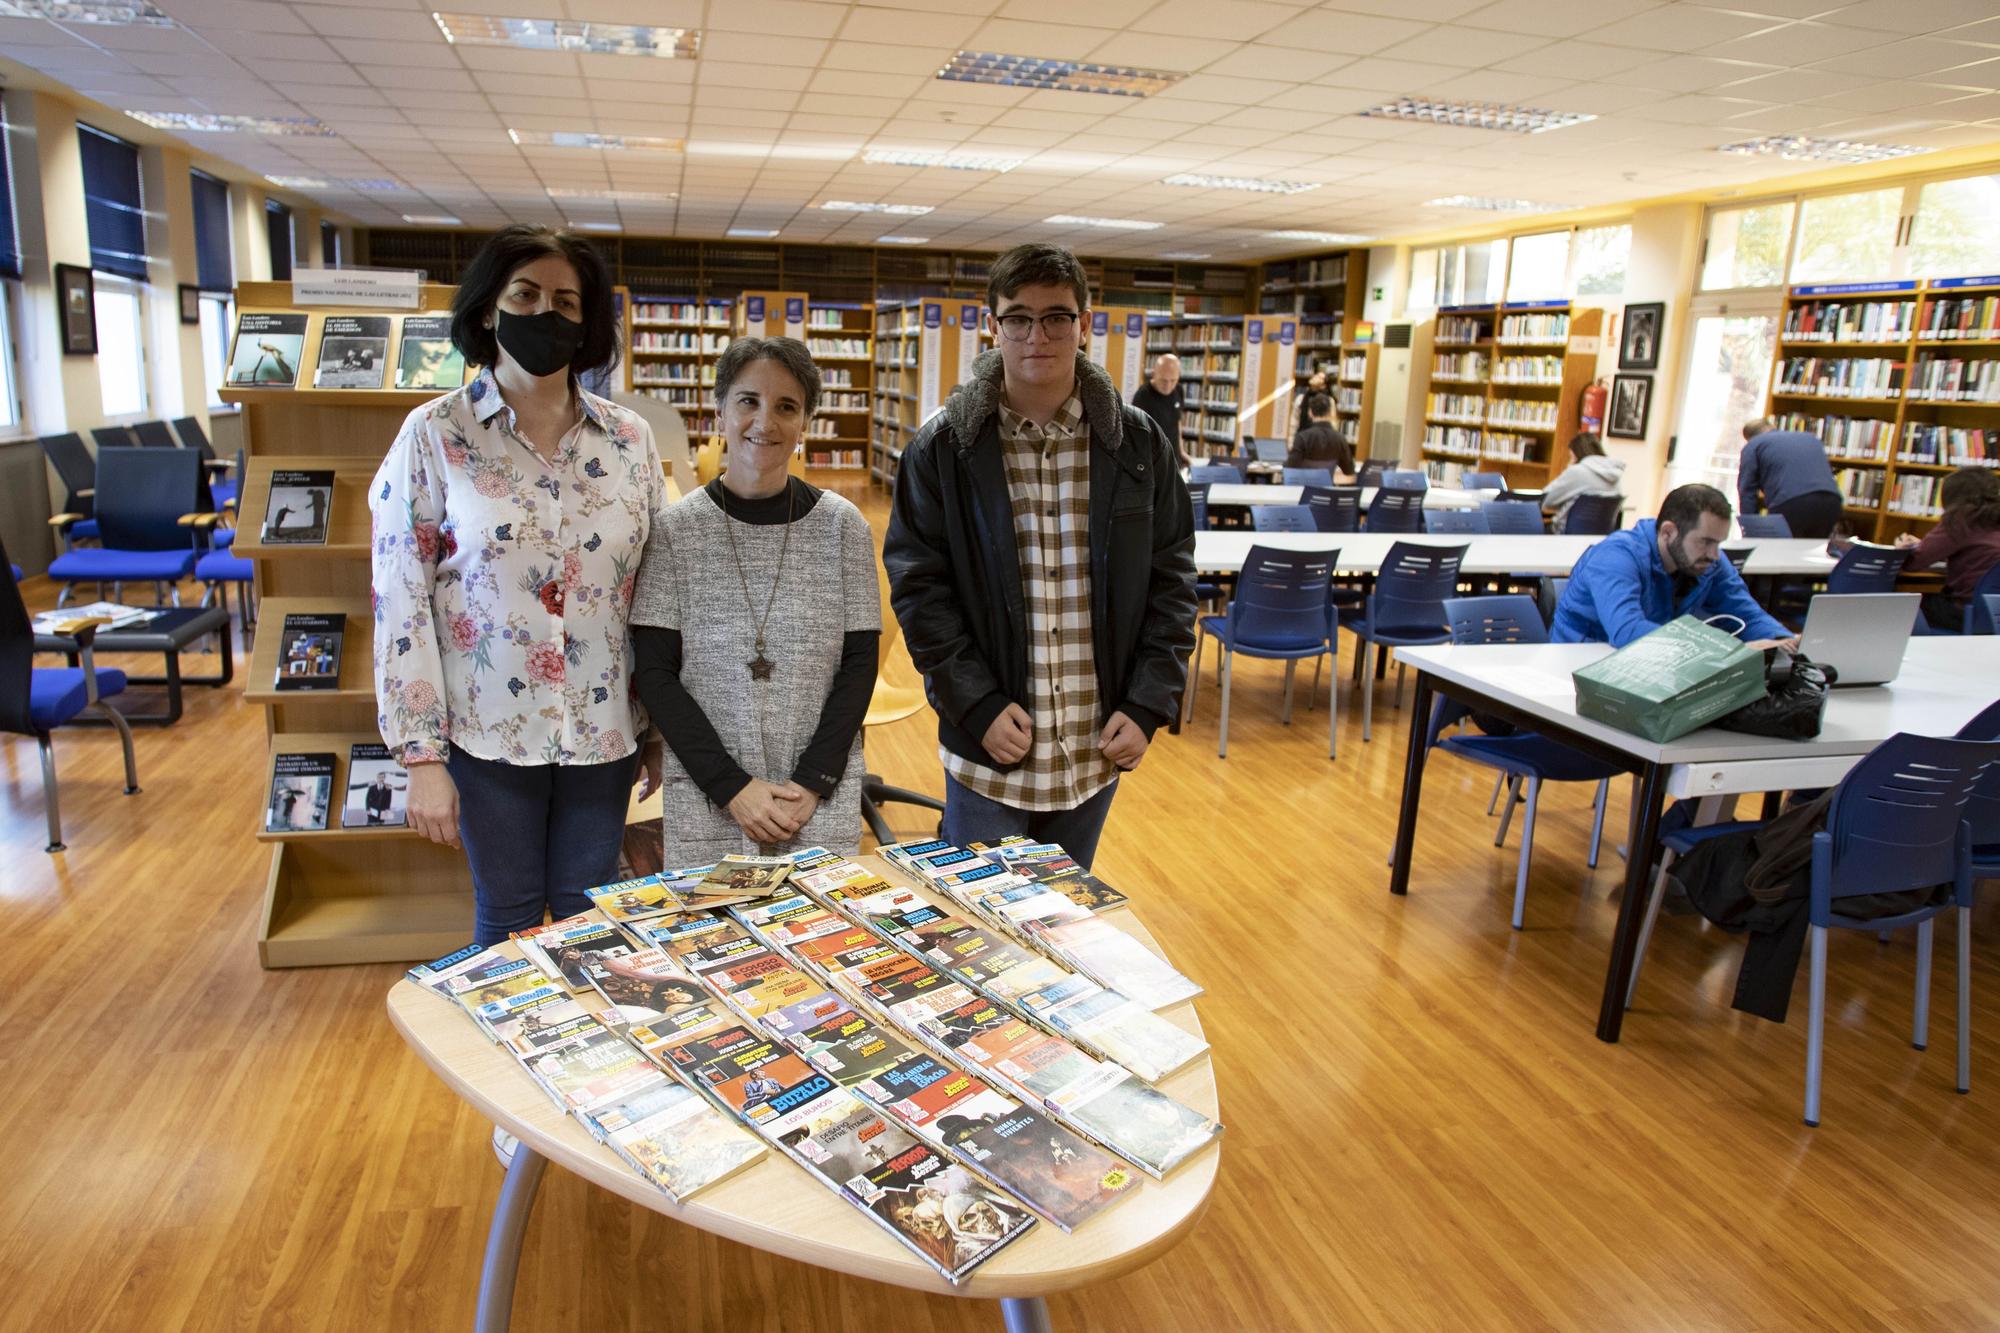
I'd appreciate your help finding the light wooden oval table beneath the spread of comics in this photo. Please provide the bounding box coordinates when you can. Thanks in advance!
[388,857,1222,1333]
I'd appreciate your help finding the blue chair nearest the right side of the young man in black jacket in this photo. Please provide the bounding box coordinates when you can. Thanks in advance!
[1182,546,1340,759]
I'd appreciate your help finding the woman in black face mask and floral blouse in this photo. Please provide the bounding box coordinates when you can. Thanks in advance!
[368,226,666,945]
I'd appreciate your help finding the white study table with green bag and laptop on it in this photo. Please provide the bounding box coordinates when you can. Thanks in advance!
[1390,640,2000,1041]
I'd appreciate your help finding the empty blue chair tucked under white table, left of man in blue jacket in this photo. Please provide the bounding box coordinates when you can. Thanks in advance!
[1428,592,1620,931]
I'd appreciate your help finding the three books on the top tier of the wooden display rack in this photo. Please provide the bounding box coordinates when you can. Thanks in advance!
[224,310,466,390]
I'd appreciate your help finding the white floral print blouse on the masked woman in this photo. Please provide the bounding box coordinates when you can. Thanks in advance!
[368,370,668,765]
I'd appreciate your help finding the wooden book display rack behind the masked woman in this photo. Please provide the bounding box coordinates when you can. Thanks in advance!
[222,282,472,967]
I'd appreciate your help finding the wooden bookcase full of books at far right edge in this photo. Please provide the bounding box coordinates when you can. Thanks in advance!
[1766,274,2000,542]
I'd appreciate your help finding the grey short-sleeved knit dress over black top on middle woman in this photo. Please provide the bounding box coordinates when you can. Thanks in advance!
[632,488,882,867]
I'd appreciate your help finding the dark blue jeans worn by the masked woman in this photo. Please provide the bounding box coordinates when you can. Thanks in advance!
[446,745,638,945]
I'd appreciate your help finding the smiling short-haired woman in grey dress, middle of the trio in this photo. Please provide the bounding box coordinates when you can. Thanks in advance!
[632,338,882,867]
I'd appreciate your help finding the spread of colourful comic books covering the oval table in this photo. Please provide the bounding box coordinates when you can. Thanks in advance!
[398,841,1222,1281]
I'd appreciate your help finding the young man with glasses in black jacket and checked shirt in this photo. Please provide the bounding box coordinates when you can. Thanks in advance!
[882,244,1194,867]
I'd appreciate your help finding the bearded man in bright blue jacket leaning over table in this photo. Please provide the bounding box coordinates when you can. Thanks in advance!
[1548,484,1798,648]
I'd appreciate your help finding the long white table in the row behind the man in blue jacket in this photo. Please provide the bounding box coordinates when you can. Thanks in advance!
[1194,528,1834,578]
